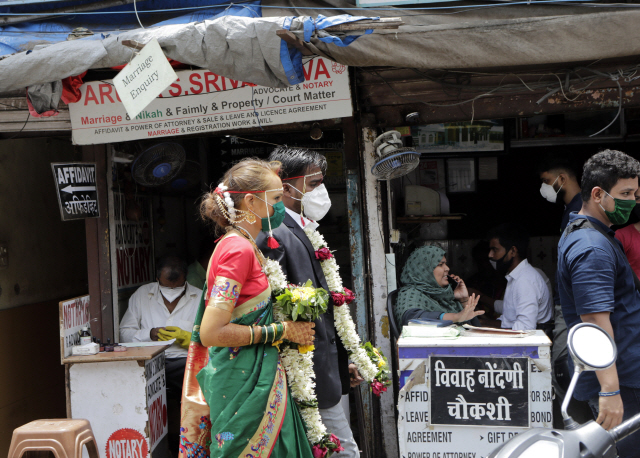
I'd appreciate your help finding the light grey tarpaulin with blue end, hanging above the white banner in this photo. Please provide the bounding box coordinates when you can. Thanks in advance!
[0,15,371,92]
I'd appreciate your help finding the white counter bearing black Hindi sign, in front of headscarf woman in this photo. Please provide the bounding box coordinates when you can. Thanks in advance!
[398,331,553,458]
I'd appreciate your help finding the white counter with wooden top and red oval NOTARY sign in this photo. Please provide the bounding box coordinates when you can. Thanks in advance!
[62,345,168,458]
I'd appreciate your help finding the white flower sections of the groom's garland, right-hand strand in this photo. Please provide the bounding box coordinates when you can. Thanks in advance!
[304,227,378,384]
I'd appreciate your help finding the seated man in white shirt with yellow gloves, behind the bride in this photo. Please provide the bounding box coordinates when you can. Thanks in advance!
[120,257,202,450]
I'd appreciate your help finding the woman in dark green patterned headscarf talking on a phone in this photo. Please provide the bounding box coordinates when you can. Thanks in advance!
[394,245,484,326]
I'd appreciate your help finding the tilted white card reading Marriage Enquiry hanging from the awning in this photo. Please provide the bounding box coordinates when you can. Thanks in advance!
[113,38,178,118]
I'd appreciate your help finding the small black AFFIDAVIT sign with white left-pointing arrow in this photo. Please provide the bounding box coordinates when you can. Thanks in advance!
[51,162,100,221]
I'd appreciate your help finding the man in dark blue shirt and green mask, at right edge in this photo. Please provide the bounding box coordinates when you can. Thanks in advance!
[557,150,640,457]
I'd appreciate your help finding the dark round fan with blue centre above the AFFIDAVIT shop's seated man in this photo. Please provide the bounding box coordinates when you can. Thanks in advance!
[131,142,187,187]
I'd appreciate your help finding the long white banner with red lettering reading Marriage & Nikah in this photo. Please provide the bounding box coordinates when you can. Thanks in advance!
[69,57,352,145]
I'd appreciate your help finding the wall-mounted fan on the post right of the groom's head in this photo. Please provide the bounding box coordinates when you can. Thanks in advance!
[371,130,420,180]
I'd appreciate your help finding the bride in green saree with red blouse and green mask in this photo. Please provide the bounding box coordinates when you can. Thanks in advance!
[180,159,314,458]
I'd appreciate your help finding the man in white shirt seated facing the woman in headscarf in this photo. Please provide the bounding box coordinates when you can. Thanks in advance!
[489,224,553,332]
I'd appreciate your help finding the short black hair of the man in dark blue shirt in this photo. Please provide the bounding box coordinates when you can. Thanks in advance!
[582,149,640,202]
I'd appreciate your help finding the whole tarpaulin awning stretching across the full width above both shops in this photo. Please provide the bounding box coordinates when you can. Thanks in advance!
[0,0,640,92]
